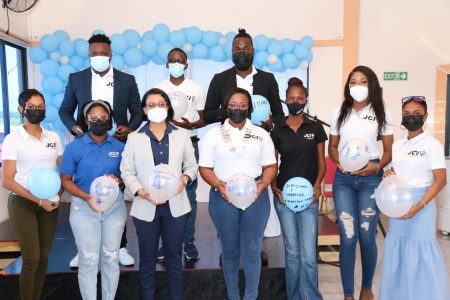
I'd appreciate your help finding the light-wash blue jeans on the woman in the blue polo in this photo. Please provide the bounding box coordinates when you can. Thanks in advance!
[69,195,127,300]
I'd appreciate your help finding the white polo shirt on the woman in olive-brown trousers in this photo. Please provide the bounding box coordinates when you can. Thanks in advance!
[2,126,63,189]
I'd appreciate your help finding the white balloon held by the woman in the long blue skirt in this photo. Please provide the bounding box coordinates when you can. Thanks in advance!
[375,175,413,218]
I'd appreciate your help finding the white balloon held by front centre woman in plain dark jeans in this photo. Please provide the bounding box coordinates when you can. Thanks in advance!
[227,174,256,210]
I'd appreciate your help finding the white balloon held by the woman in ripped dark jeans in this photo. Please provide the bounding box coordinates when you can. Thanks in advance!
[339,138,370,172]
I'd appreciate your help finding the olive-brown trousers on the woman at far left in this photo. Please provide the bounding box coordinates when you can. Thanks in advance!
[8,194,58,300]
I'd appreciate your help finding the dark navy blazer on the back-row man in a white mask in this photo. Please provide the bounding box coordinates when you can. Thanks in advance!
[59,68,144,131]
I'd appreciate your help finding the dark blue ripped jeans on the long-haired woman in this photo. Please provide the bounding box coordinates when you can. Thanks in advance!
[333,166,382,297]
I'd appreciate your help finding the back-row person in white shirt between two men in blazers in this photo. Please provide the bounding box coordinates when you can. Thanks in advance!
[155,48,206,261]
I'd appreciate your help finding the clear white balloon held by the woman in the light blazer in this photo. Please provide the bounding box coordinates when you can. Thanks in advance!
[148,164,180,200]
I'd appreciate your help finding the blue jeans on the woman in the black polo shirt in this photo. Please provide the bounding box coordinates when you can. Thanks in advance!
[273,194,322,300]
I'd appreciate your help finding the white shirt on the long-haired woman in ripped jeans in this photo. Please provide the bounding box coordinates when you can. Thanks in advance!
[330,104,394,159]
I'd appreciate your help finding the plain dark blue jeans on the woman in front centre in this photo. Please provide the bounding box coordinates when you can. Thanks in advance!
[209,189,270,300]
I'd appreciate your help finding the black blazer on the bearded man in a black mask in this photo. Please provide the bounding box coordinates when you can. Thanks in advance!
[204,67,284,126]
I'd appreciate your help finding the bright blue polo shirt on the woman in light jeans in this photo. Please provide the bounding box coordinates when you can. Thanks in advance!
[61,133,125,193]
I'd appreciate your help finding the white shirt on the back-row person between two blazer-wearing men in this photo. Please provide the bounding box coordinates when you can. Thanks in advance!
[155,78,206,136]
